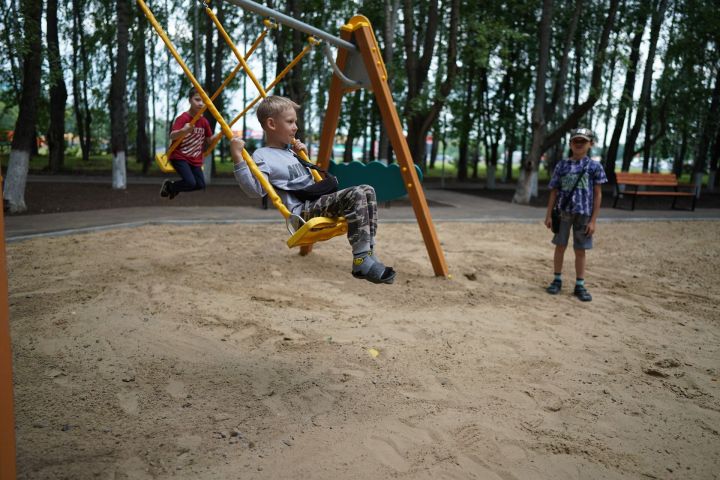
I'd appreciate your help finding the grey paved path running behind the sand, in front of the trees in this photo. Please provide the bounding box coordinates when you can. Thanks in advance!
[5,177,720,242]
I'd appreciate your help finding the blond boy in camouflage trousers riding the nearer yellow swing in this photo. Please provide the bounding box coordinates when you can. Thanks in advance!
[230,95,396,284]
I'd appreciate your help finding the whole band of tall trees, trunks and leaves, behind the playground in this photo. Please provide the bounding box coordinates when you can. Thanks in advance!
[0,0,720,210]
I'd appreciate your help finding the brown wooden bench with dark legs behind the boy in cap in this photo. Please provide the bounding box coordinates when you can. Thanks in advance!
[613,172,695,211]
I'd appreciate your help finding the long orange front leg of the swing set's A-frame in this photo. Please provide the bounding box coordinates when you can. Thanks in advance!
[350,15,449,277]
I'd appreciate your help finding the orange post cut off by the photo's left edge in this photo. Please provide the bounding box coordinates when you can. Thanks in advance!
[0,176,16,480]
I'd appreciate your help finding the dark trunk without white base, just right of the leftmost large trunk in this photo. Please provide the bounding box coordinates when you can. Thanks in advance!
[47,0,67,173]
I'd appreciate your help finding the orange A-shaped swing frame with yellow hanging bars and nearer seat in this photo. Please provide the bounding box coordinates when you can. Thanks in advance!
[137,0,449,277]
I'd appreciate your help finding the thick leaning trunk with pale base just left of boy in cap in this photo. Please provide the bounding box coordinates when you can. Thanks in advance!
[513,0,553,205]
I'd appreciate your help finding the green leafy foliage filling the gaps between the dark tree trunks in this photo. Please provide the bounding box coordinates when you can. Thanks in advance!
[0,0,720,184]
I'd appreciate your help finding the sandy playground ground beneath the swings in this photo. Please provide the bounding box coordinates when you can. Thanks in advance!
[8,221,720,480]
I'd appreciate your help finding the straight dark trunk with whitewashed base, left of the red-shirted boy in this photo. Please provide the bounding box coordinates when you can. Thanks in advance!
[110,0,130,190]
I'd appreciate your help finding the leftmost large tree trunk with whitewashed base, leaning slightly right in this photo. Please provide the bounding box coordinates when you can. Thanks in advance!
[3,0,43,213]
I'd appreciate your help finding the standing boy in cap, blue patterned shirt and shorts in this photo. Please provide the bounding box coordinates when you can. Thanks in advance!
[545,128,607,302]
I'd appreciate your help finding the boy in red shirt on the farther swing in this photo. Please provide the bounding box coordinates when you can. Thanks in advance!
[160,88,212,200]
